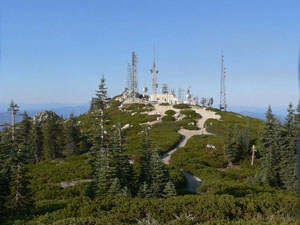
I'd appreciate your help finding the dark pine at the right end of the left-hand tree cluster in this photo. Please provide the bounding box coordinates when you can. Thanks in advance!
[65,112,80,156]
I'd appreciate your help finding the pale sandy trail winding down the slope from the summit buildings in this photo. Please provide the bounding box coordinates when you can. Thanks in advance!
[155,106,221,192]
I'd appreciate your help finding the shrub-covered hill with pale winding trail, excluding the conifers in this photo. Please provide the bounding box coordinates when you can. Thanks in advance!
[3,90,298,224]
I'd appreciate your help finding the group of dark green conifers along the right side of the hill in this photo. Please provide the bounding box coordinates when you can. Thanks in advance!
[224,104,300,191]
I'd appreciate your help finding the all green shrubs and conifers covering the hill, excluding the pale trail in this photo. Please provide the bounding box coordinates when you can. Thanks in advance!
[0,78,300,225]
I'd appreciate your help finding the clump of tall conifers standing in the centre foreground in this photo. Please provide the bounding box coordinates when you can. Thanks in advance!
[86,77,176,198]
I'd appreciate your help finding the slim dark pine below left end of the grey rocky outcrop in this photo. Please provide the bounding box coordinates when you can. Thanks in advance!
[30,120,44,163]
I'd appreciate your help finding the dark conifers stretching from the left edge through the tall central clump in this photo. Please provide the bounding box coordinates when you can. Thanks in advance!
[0,77,176,215]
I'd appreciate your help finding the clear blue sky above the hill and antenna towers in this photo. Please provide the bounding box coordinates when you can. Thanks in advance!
[0,0,300,106]
